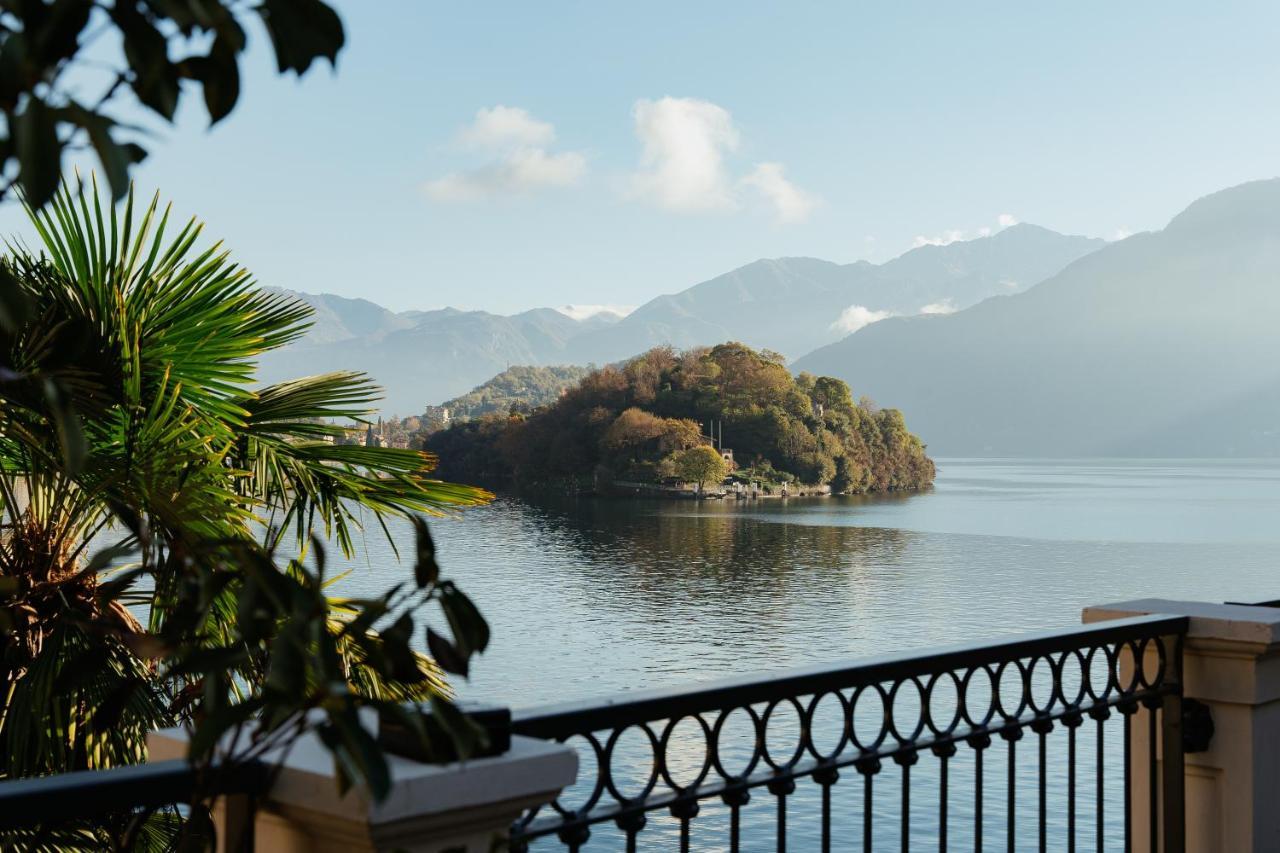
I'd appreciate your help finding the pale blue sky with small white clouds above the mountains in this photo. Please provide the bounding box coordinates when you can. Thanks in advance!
[0,0,1280,313]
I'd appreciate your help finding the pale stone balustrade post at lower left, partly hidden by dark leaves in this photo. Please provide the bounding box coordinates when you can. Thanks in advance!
[147,712,577,853]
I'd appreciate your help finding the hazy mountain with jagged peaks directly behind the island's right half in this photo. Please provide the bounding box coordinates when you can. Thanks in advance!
[568,225,1105,362]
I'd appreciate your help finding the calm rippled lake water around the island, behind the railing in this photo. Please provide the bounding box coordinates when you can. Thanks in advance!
[332,460,1280,850]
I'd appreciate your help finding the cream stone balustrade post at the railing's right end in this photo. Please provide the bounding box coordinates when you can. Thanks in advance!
[1084,598,1280,853]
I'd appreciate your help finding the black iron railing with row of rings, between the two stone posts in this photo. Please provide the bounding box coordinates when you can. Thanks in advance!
[511,616,1188,853]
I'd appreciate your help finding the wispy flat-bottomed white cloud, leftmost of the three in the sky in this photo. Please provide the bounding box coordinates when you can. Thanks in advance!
[422,104,586,201]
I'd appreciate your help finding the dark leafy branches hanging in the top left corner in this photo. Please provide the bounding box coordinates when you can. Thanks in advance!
[0,0,346,207]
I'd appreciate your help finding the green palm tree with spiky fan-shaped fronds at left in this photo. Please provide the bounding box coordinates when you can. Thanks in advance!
[0,184,489,777]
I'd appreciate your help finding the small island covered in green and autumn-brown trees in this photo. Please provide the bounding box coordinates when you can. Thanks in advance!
[425,343,934,493]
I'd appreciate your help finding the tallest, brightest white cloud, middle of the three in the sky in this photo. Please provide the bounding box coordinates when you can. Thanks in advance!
[631,97,740,210]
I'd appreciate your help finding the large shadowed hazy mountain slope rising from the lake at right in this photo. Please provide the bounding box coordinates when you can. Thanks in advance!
[794,181,1280,456]
